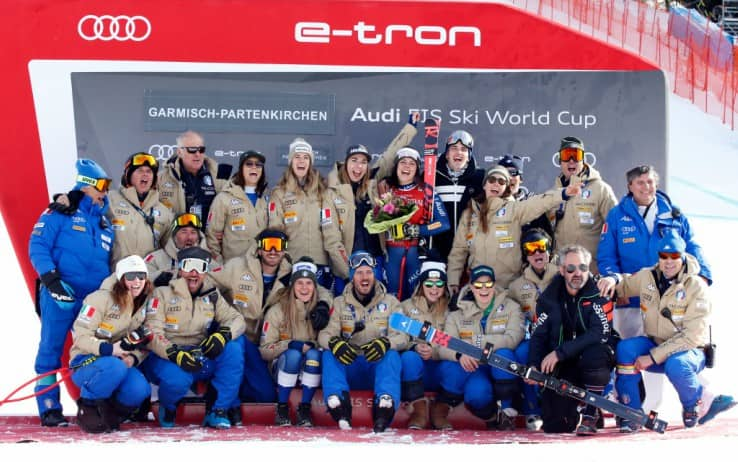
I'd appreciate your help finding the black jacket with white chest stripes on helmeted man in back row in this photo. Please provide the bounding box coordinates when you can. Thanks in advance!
[432,154,485,261]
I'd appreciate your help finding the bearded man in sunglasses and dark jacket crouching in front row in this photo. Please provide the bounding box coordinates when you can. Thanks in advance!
[528,244,618,436]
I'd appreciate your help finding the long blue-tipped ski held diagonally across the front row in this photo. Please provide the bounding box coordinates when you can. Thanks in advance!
[390,313,668,433]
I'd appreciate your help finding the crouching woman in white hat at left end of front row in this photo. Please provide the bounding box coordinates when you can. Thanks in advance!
[69,255,153,433]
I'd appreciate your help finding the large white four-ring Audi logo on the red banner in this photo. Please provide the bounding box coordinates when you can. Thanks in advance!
[77,14,151,42]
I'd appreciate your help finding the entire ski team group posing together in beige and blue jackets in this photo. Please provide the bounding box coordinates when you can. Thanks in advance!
[29,113,735,435]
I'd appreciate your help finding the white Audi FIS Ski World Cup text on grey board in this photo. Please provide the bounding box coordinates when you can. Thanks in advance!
[350,107,597,129]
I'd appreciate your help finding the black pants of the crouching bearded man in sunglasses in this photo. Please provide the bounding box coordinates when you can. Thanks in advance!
[541,345,615,433]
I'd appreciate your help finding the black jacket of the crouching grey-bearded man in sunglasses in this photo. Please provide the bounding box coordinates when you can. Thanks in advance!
[528,274,618,369]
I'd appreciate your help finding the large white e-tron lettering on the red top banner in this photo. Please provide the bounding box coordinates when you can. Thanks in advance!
[295,21,482,47]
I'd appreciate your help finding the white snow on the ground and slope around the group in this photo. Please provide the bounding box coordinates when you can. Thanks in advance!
[0,95,738,461]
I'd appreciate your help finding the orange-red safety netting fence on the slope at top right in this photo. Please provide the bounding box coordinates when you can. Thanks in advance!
[512,0,738,130]
